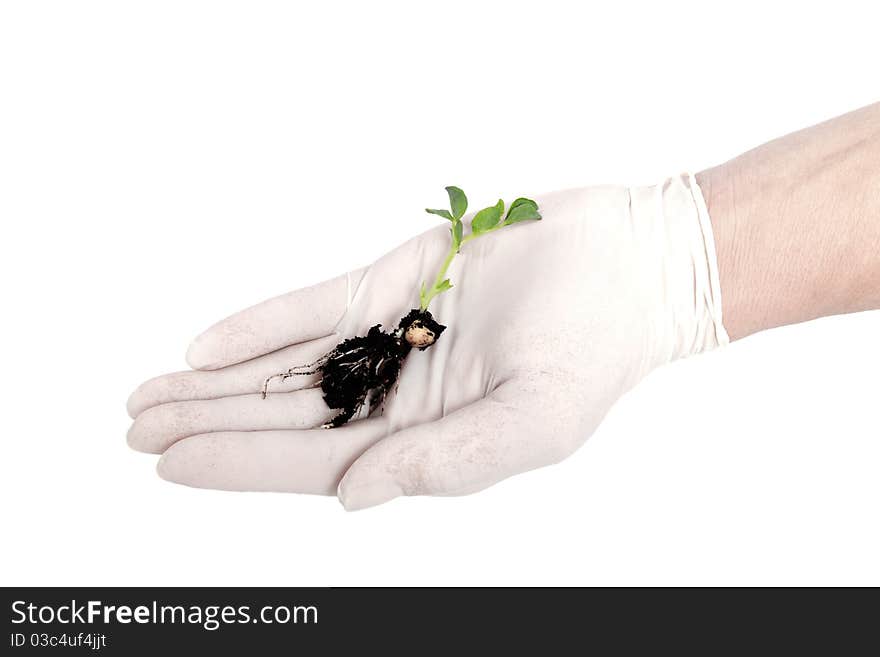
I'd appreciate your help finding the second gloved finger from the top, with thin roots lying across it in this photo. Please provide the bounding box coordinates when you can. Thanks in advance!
[128,335,339,418]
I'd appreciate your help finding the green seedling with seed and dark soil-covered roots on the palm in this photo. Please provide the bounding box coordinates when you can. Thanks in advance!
[262,187,541,428]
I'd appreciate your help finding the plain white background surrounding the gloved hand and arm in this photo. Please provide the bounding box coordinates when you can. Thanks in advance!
[0,1,880,585]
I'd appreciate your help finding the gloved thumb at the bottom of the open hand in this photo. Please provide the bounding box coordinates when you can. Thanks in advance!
[337,379,584,510]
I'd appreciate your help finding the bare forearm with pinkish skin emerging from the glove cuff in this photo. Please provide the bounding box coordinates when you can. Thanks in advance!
[697,103,880,339]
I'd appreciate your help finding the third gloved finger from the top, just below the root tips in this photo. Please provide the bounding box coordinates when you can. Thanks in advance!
[128,388,334,454]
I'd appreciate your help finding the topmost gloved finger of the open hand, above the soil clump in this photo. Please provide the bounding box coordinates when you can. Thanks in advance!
[186,269,366,370]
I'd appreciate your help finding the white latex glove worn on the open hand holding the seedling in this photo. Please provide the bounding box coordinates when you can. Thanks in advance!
[128,175,728,509]
